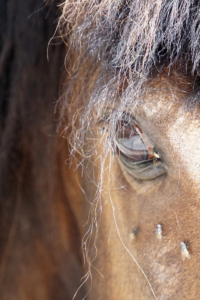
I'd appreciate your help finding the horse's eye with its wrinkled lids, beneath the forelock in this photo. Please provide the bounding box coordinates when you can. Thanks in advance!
[113,114,166,180]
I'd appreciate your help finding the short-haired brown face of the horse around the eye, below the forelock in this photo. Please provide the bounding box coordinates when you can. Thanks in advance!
[88,72,200,300]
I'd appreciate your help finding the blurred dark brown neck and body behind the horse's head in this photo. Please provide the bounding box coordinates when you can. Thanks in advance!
[0,0,86,300]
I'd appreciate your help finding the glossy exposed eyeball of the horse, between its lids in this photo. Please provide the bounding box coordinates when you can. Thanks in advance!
[115,121,153,162]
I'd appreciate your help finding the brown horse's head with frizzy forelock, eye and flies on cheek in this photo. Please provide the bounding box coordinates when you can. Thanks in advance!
[61,0,200,300]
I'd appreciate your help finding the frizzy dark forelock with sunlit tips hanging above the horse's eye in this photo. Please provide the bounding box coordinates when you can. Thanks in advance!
[59,0,200,157]
